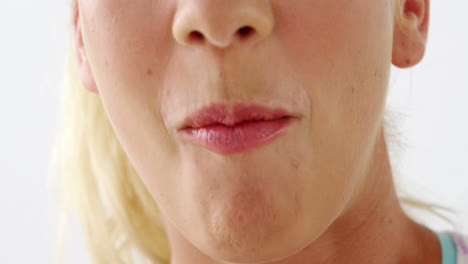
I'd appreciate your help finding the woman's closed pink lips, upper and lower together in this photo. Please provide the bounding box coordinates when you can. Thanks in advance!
[179,104,295,154]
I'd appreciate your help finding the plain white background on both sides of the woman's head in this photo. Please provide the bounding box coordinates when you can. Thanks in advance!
[0,0,468,263]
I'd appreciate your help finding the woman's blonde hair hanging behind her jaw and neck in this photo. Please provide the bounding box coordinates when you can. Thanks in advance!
[55,0,458,264]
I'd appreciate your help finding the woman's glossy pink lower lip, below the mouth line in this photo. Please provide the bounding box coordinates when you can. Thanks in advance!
[181,118,291,154]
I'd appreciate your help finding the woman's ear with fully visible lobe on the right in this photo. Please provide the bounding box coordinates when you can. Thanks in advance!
[392,0,429,68]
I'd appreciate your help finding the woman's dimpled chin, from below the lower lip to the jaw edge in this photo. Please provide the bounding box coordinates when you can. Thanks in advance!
[177,136,315,263]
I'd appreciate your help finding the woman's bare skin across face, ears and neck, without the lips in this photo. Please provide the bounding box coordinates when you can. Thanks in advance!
[74,0,441,264]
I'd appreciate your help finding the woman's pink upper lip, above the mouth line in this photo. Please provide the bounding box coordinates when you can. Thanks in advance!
[179,103,297,130]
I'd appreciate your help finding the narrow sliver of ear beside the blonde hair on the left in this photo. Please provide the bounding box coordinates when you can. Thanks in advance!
[73,4,98,94]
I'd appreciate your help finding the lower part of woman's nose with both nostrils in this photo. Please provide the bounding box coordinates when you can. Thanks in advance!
[172,0,274,48]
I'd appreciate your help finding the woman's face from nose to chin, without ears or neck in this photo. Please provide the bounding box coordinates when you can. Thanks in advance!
[79,0,400,261]
